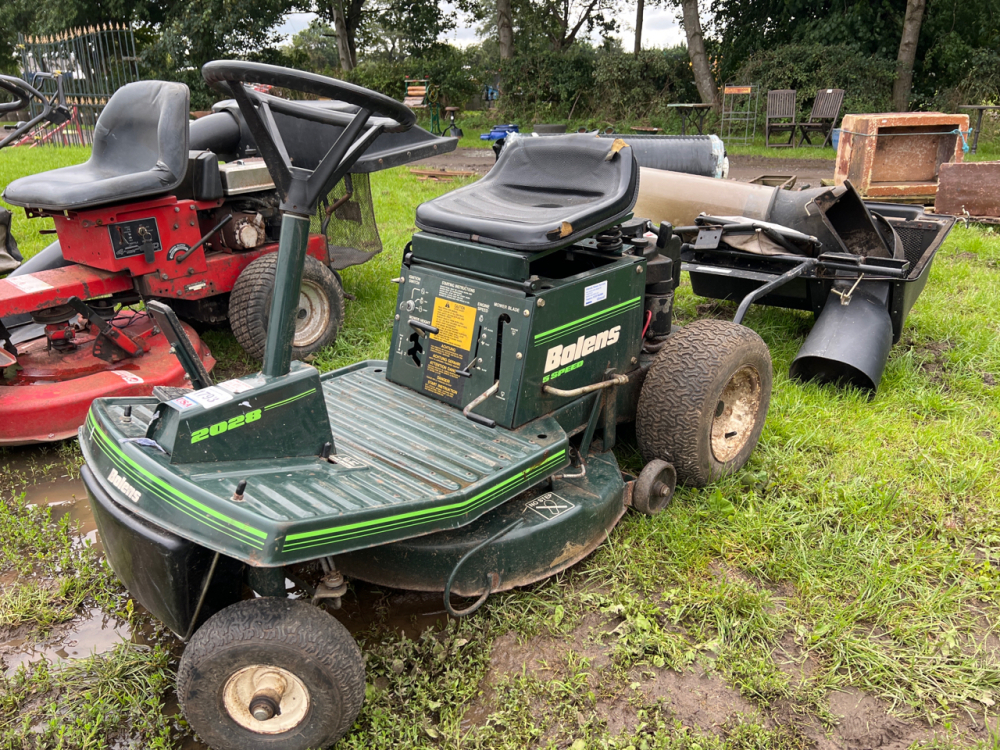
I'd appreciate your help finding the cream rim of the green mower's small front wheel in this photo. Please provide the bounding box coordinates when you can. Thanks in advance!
[222,664,309,734]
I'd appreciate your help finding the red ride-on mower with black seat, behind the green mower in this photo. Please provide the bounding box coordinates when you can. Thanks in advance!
[0,72,457,445]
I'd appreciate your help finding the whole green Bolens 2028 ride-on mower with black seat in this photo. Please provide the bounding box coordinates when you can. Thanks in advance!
[80,61,771,750]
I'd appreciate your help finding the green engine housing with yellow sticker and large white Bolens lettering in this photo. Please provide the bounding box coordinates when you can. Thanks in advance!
[388,233,646,429]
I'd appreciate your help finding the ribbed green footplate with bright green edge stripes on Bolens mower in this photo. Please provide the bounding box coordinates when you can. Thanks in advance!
[80,362,569,566]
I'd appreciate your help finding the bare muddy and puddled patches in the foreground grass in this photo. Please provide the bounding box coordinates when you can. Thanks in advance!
[0,448,997,750]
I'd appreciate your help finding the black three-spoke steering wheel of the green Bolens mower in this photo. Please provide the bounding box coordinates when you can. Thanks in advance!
[201,60,416,216]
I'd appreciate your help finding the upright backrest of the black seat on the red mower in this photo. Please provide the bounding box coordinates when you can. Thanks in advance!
[90,81,189,190]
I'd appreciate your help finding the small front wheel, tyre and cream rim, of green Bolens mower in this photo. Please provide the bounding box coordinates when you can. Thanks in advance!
[177,598,365,750]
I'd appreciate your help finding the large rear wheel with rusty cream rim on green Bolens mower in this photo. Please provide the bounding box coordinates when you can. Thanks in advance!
[636,320,772,487]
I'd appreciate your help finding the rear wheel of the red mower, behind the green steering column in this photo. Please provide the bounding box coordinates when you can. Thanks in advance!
[229,253,344,359]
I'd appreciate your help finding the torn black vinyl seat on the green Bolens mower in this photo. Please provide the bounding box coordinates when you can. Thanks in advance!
[416,133,639,252]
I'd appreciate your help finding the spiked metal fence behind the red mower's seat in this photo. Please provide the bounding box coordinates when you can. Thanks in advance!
[18,24,139,145]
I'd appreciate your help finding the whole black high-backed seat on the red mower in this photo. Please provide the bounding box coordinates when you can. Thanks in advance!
[3,81,189,211]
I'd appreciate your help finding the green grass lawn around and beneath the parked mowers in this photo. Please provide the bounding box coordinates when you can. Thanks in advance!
[0,144,1000,750]
